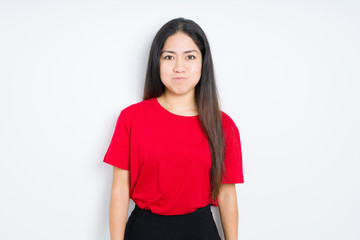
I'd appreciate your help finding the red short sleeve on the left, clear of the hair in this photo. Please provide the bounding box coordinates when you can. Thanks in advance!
[103,110,130,170]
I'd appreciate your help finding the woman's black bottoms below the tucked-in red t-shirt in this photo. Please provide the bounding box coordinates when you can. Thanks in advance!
[124,204,221,240]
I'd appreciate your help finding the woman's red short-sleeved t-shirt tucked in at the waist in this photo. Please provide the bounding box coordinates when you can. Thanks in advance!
[103,97,244,215]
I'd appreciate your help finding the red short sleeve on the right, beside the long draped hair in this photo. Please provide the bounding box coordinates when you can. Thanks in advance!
[221,113,244,184]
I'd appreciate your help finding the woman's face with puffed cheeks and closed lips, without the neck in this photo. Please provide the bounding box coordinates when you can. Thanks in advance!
[160,32,202,96]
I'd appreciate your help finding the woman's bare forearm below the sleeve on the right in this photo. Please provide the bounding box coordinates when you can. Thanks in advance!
[218,184,239,240]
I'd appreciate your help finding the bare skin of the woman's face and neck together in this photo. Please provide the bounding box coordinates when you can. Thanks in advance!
[157,32,202,116]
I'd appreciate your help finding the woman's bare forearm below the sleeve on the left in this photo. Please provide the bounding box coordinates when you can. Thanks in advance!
[109,167,130,240]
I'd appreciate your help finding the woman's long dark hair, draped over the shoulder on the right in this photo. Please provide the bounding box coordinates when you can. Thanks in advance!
[143,18,226,201]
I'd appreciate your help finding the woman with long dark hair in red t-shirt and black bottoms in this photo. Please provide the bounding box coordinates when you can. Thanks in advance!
[104,18,244,240]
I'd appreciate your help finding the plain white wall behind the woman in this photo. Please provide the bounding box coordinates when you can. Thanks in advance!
[0,0,360,240]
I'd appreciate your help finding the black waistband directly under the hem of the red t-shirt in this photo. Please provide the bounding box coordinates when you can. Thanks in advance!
[132,204,212,223]
